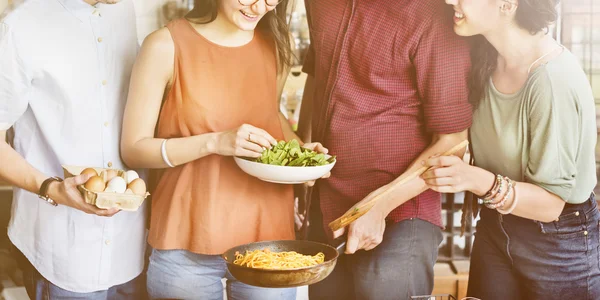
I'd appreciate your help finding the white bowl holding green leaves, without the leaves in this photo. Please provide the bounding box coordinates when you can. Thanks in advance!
[233,155,336,184]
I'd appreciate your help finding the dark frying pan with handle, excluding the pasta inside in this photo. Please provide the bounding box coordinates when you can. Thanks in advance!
[221,236,346,288]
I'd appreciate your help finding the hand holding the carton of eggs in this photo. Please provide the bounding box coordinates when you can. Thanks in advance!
[48,174,120,217]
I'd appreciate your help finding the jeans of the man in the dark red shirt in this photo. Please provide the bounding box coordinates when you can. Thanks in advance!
[309,205,442,300]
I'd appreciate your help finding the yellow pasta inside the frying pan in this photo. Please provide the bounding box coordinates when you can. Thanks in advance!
[233,249,325,270]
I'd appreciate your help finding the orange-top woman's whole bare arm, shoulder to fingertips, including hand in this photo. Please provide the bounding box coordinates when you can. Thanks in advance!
[121,28,276,168]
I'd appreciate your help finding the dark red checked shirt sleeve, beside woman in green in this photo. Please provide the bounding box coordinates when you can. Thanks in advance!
[413,10,472,134]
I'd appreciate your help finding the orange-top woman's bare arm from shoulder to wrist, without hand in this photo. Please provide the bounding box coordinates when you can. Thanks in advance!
[121,28,216,168]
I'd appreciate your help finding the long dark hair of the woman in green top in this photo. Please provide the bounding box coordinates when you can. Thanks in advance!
[469,0,558,108]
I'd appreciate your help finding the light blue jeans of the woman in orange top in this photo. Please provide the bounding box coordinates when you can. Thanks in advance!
[147,249,296,300]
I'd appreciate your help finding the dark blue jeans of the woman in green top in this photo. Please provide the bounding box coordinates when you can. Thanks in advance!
[467,196,600,300]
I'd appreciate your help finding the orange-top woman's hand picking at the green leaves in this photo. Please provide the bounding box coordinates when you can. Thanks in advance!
[215,124,277,158]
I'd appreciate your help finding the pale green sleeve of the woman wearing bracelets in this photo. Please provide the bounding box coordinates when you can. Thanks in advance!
[525,74,581,201]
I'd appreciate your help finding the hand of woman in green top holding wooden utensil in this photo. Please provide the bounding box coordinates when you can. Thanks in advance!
[421,156,486,194]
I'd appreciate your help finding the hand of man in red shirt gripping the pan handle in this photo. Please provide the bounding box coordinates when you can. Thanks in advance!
[333,195,385,254]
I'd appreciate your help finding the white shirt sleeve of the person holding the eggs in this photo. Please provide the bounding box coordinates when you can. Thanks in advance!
[0,23,30,130]
